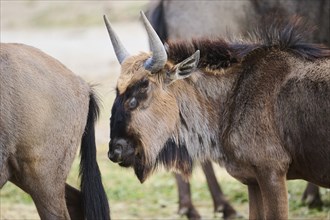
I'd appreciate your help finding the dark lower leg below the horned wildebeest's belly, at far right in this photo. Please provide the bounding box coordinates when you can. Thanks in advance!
[302,183,323,208]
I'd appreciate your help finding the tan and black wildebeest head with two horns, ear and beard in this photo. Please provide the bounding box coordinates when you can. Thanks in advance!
[104,12,207,182]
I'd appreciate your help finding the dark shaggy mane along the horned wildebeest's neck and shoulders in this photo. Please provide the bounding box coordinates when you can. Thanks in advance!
[167,15,330,69]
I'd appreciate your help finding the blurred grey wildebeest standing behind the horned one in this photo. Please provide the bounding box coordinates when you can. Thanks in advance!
[147,0,330,214]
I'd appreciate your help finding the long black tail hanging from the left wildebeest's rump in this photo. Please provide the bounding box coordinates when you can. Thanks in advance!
[79,92,110,220]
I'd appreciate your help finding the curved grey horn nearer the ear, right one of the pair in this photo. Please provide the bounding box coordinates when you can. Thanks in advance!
[140,11,167,73]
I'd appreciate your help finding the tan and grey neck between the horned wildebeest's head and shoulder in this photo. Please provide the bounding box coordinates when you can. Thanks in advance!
[166,69,236,165]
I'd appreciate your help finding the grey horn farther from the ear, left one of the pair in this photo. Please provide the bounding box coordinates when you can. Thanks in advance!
[103,15,130,64]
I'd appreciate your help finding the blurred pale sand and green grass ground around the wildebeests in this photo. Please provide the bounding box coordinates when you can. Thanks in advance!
[0,0,330,220]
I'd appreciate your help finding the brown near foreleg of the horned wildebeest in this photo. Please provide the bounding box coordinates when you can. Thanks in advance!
[257,170,289,219]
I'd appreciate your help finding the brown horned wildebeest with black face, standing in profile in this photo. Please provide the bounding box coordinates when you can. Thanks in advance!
[105,13,330,219]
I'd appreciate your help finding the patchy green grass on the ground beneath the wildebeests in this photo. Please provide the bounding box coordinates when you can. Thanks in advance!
[0,145,330,219]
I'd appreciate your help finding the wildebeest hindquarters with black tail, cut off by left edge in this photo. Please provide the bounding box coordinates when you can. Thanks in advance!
[0,43,110,219]
